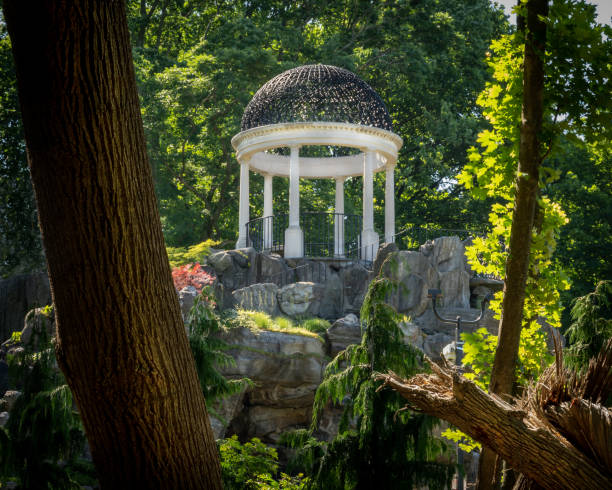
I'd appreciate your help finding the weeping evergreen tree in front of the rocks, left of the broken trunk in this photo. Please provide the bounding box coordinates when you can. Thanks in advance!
[293,277,455,490]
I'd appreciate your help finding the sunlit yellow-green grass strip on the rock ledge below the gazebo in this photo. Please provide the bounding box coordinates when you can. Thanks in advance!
[229,310,329,340]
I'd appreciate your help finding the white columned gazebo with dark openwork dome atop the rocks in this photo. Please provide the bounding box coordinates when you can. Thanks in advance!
[232,65,402,260]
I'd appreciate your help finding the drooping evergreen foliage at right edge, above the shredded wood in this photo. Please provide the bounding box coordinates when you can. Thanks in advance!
[565,281,612,369]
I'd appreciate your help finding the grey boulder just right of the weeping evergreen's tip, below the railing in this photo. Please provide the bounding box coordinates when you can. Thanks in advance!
[382,251,438,317]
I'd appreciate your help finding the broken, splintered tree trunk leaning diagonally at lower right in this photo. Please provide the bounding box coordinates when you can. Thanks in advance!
[378,364,612,490]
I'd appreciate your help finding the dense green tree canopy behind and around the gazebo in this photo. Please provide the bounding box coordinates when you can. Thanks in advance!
[128,0,507,246]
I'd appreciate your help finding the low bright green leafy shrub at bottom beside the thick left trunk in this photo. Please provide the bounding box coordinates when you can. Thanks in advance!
[217,435,308,490]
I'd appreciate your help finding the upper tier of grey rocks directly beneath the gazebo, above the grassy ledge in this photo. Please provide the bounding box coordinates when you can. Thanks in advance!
[208,237,503,344]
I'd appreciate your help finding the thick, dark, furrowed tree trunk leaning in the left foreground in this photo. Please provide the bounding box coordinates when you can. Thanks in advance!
[3,0,221,489]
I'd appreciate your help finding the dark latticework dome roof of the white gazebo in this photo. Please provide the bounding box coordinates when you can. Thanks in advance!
[241,65,393,131]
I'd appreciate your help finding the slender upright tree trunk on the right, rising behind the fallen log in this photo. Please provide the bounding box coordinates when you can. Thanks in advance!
[478,0,548,490]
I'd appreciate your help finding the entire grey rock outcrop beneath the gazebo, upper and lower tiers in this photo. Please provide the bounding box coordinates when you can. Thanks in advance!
[203,237,502,443]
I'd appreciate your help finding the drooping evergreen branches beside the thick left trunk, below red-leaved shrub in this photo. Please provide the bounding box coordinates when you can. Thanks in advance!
[187,287,250,406]
